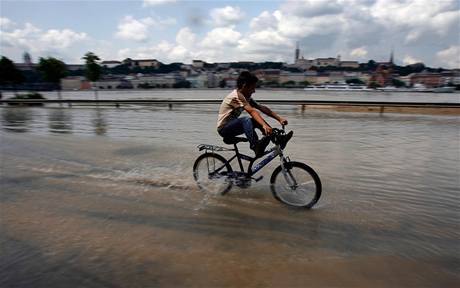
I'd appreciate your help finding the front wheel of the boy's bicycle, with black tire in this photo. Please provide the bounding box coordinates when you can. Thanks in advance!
[270,162,321,209]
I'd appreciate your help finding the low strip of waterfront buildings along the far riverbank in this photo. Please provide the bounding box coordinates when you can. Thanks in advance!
[61,67,460,90]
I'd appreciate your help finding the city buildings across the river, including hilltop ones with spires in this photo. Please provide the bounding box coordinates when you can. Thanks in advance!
[11,47,460,90]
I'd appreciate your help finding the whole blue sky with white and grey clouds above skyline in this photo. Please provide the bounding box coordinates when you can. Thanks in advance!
[0,0,460,68]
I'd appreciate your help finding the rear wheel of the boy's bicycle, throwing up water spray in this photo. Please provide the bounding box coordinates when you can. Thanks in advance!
[193,153,233,195]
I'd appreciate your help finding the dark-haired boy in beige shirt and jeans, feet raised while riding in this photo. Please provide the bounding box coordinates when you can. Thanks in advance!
[217,71,293,158]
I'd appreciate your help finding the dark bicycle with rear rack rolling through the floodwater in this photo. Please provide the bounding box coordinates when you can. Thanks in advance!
[193,126,322,209]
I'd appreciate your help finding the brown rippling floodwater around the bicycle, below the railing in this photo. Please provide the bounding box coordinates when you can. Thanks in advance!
[0,92,460,287]
